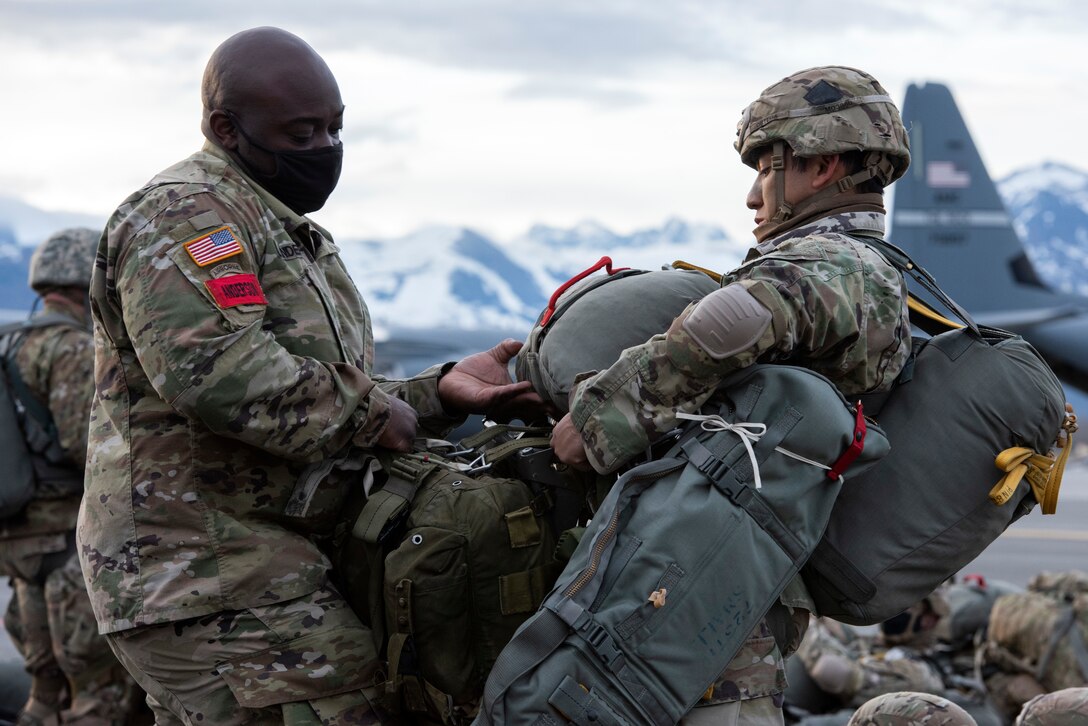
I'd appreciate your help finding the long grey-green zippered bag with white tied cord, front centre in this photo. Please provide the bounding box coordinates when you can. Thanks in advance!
[474,365,888,726]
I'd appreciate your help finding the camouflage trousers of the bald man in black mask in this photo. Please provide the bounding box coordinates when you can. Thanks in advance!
[108,589,387,726]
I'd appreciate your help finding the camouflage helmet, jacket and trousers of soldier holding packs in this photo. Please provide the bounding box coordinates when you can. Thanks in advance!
[570,69,911,723]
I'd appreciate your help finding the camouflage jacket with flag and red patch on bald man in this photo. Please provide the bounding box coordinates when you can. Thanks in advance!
[77,145,456,632]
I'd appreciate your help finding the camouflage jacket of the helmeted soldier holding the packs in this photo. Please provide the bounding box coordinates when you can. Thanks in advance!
[570,212,911,473]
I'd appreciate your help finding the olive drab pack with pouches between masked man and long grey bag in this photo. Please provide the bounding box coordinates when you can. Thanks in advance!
[342,426,596,724]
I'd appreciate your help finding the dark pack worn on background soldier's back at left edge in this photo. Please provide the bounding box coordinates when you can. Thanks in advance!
[0,313,83,519]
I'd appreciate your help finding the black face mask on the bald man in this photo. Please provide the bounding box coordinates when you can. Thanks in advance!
[230,113,344,214]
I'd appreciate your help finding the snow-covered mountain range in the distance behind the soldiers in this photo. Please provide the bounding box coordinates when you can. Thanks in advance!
[0,163,1088,331]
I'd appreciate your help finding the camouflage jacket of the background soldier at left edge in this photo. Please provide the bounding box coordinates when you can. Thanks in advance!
[0,295,95,540]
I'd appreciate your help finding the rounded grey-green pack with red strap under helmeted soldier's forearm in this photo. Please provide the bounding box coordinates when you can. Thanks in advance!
[515,257,719,413]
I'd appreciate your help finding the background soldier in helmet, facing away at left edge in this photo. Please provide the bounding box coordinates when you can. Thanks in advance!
[0,227,143,725]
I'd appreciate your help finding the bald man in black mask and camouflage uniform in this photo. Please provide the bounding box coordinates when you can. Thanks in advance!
[78,27,539,725]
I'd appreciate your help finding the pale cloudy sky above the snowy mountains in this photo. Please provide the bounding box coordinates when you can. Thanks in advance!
[0,0,1088,238]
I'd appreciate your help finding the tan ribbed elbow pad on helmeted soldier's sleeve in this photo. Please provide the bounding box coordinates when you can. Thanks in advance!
[682,284,771,360]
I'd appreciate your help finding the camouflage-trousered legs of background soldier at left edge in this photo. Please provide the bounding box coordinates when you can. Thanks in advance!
[0,534,143,726]
